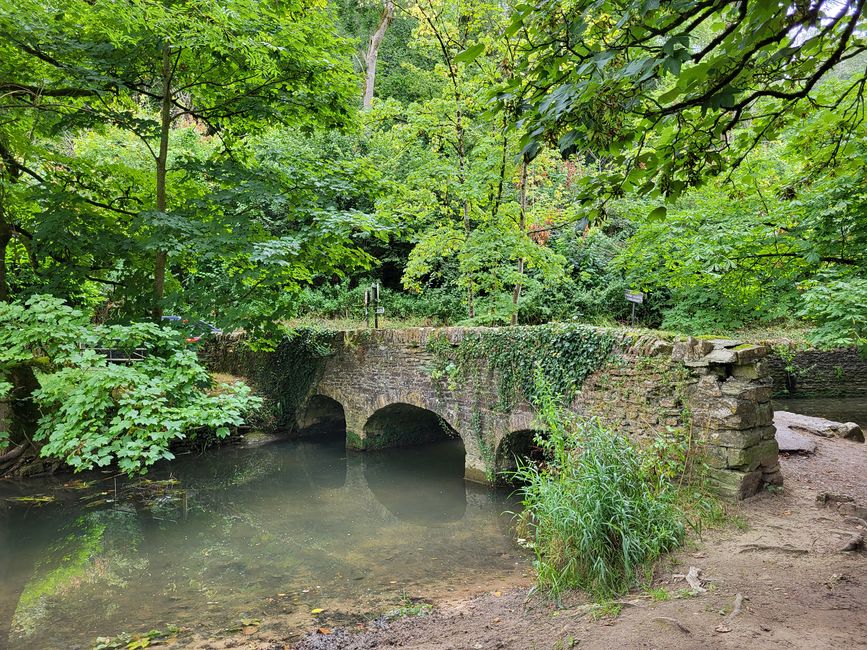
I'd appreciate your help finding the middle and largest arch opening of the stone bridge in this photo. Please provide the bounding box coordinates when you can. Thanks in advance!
[364,402,460,449]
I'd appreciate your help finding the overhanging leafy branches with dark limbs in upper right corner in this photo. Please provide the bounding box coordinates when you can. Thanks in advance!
[500,0,867,205]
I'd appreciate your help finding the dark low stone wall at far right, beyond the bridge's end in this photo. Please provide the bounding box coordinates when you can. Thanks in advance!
[768,348,867,397]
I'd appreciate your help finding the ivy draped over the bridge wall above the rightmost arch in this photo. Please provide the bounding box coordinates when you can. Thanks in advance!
[428,324,614,412]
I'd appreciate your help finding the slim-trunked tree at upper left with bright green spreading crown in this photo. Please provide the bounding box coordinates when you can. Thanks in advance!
[0,0,353,319]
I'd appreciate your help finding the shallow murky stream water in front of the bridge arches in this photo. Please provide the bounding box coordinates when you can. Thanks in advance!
[0,432,525,650]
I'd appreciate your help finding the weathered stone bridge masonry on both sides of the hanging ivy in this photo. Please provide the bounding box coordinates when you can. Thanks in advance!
[212,326,782,499]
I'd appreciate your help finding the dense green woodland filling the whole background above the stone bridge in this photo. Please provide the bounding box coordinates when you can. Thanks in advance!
[0,0,867,471]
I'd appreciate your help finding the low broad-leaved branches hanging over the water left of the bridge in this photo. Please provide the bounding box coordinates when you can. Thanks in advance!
[0,296,259,474]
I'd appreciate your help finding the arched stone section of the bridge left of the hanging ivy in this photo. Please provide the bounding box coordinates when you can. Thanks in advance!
[297,329,534,482]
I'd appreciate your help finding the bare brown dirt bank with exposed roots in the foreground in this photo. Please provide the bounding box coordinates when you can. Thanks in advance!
[178,430,867,650]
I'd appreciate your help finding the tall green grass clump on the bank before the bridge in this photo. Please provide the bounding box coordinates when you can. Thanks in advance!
[515,372,685,600]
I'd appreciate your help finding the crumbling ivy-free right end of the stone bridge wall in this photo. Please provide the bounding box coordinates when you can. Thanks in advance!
[574,334,782,499]
